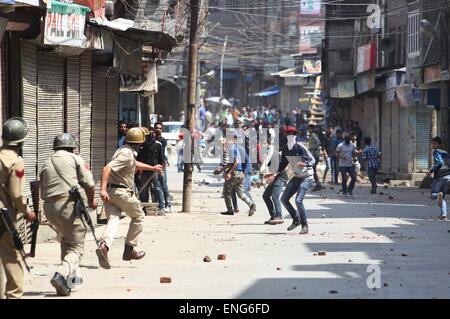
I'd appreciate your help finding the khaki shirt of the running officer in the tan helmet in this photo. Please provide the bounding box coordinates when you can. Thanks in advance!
[108,145,137,189]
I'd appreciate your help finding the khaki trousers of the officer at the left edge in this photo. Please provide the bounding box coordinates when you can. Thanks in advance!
[0,232,23,299]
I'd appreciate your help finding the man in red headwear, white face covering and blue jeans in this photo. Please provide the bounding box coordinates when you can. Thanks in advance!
[266,127,316,235]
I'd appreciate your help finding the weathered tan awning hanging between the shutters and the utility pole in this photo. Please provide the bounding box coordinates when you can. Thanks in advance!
[120,62,158,93]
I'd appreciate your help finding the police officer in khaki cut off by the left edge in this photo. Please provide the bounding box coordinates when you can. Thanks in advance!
[0,117,36,299]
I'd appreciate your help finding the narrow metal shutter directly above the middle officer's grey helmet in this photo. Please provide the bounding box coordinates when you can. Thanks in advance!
[66,56,80,153]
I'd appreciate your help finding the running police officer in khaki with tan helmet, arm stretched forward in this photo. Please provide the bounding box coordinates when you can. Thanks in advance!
[97,127,163,269]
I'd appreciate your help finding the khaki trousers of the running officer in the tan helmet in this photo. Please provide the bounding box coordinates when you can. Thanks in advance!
[102,188,145,247]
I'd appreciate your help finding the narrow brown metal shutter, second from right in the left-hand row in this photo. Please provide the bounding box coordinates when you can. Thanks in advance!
[91,68,107,188]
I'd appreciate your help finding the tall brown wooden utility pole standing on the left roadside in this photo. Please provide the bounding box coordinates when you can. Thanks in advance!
[182,0,200,213]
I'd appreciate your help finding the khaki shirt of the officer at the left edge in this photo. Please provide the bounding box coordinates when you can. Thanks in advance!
[0,147,30,221]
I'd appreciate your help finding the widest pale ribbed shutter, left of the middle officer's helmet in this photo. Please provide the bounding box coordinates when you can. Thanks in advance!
[38,53,64,175]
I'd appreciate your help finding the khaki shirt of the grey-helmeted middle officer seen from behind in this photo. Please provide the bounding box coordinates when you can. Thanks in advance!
[41,150,95,200]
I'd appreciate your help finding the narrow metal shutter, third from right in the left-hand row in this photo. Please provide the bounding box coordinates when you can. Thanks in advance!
[80,53,92,165]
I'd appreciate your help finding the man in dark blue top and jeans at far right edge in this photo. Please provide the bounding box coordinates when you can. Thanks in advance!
[428,137,450,220]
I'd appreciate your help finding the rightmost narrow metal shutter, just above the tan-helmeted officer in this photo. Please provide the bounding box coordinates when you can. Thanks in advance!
[106,76,119,161]
